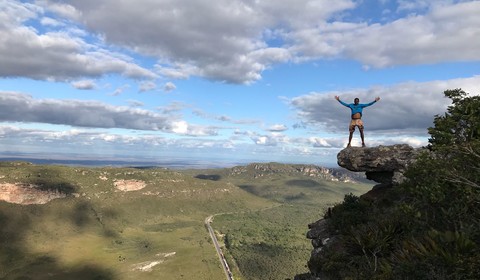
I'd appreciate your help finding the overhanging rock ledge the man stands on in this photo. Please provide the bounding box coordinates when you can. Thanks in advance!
[337,144,421,187]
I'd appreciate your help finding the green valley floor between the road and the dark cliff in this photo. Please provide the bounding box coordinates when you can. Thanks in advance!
[191,167,371,280]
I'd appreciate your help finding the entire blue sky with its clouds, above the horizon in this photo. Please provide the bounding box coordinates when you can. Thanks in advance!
[0,0,480,166]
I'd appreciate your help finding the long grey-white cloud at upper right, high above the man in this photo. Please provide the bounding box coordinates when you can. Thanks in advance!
[286,1,480,68]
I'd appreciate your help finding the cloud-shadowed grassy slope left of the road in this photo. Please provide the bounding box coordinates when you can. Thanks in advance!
[0,164,272,279]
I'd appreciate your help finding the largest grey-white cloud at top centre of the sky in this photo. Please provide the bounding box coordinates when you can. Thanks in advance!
[35,0,355,83]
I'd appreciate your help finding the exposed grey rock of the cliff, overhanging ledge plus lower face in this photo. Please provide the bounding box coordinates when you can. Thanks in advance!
[294,145,421,280]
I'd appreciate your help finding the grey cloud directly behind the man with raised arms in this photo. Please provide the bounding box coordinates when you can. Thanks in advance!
[291,76,480,135]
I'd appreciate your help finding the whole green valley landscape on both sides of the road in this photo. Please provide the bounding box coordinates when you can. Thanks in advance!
[0,163,372,280]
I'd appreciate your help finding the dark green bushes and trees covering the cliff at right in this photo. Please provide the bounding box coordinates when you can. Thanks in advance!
[316,89,480,279]
